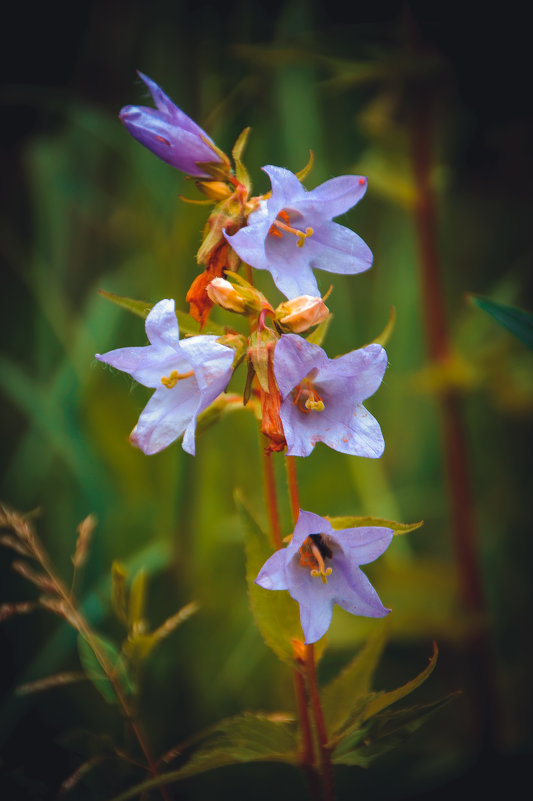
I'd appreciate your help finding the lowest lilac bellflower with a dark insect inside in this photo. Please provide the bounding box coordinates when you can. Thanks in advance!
[255,510,393,644]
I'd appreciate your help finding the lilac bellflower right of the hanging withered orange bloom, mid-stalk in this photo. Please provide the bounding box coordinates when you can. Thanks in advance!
[274,334,387,459]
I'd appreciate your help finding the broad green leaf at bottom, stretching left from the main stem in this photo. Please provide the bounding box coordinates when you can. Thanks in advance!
[106,713,298,801]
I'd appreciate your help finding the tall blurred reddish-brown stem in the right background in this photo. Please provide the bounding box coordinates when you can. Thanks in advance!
[412,92,497,731]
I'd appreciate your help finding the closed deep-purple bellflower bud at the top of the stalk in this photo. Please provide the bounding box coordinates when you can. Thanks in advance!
[119,72,221,178]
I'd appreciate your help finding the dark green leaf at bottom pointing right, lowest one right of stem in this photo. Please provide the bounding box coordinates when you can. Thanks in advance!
[332,693,458,767]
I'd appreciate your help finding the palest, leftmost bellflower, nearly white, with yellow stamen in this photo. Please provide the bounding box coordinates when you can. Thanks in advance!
[96,300,234,454]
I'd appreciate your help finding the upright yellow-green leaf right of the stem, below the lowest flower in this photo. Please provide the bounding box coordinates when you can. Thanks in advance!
[321,622,388,735]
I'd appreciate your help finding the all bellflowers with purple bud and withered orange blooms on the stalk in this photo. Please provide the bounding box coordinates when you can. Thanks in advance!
[96,74,393,643]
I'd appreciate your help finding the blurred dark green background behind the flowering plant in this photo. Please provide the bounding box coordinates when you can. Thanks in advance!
[0,0,533,800]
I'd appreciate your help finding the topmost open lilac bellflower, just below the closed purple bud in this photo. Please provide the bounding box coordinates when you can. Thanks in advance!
[226,166,372,298]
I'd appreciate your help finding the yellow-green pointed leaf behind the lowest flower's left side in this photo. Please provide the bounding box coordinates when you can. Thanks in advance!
[235,491,304,667]
